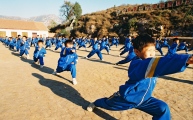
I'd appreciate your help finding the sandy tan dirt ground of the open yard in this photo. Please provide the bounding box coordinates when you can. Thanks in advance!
[0,43,193,120]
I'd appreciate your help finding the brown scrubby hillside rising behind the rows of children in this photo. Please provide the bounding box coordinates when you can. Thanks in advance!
[52,2,193,37]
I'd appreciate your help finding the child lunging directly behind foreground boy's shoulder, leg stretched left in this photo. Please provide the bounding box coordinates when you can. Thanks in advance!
[115,46,136,65]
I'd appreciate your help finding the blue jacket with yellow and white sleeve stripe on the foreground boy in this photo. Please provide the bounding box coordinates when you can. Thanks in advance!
[119,54,190,107]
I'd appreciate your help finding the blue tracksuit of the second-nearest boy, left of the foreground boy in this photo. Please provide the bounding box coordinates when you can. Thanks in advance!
[56,47,78,78]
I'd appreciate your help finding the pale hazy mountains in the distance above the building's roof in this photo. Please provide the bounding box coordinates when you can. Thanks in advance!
[0,14,62,26]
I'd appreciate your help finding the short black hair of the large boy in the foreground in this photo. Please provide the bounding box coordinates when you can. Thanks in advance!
[132,34,155,51]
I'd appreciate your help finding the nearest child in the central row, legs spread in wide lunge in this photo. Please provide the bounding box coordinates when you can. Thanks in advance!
[86,37,103,60]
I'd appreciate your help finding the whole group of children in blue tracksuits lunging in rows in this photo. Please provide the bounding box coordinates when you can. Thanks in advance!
[0,34,193,120]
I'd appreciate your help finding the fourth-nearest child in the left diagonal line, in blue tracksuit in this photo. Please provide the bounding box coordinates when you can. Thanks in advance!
[20,36,30,59]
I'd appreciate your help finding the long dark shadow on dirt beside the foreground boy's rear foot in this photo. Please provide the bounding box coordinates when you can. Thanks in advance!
[32,73,116,120]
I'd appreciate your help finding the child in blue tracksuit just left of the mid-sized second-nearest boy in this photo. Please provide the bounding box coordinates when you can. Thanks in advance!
[33,40,46,68]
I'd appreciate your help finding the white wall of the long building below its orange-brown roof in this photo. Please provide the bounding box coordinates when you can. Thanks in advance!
[0,29,48,37]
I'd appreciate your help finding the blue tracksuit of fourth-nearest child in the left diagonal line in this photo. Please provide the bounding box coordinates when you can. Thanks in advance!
[20,41,30,56]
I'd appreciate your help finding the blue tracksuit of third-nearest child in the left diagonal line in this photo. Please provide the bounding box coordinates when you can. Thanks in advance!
[33,46,46,65]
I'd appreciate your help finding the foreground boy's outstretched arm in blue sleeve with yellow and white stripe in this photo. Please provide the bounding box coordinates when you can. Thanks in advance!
[128,54,193,81]
